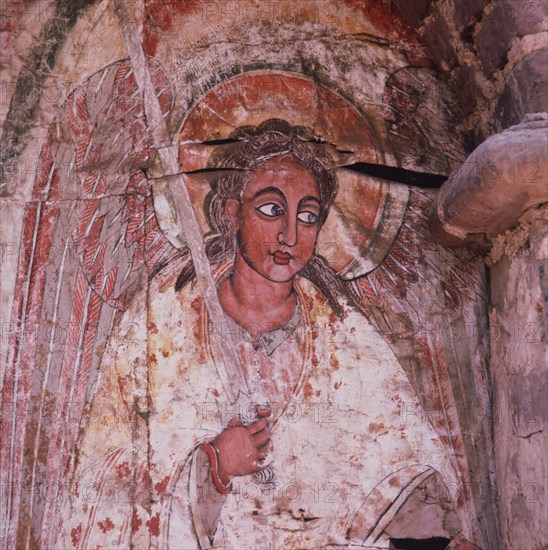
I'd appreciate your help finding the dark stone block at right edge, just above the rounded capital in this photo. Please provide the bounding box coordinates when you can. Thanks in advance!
[496,49,548,128]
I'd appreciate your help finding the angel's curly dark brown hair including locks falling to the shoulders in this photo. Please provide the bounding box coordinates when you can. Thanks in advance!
[175,119,355,316]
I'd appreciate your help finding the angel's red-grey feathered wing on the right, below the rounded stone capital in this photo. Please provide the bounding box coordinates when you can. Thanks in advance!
[351,189,496,540]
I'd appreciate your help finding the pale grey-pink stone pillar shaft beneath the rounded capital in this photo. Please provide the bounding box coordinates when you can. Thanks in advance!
[490,209,548,548]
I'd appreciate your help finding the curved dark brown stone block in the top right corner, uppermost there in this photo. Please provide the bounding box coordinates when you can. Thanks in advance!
[476,0,548,75]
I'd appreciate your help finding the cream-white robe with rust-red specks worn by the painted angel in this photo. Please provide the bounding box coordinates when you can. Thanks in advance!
[59,266,457,550]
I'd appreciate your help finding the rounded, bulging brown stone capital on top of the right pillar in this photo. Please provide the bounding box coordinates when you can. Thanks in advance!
[431,115,548,245]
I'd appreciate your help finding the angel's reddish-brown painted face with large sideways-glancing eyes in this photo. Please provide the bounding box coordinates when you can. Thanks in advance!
[227,155,321,283]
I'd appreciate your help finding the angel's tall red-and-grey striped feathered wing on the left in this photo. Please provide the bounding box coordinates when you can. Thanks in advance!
[0,61,179,548]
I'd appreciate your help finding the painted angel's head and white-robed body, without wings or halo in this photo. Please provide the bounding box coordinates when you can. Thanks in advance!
[52,120,470,549]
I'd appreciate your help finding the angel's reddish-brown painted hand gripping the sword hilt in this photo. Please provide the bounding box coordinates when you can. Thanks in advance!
[213,407,272,484]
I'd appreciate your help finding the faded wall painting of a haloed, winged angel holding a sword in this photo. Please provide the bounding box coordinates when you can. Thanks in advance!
[6,2,540,549]
